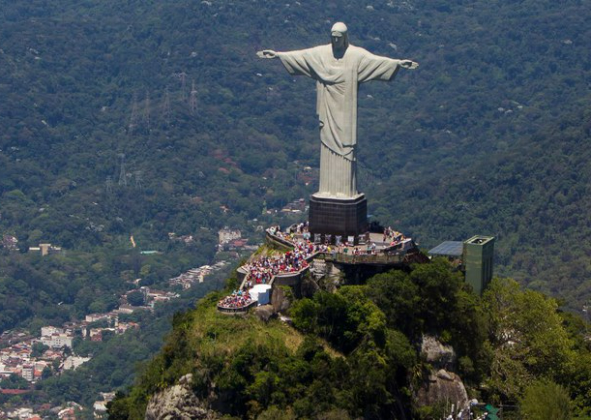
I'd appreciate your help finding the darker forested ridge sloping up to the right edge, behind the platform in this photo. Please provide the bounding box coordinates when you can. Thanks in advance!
[379,109,591,309]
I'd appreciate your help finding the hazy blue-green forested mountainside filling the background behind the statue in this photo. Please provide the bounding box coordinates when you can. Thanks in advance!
[0,0,591,327]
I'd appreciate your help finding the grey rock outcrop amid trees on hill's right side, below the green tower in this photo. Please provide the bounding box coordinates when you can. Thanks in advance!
[415,336,468,409]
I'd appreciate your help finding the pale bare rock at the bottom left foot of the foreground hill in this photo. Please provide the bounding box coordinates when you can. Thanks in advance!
[145,374,220,420]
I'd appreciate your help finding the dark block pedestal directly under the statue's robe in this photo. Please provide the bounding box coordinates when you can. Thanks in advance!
[309,194,367,242]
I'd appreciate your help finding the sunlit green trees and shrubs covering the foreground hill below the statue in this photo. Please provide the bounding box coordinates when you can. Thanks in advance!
[109,260,591,420]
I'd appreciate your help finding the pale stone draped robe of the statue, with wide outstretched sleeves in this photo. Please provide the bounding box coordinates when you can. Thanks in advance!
[277,44,400,198]
